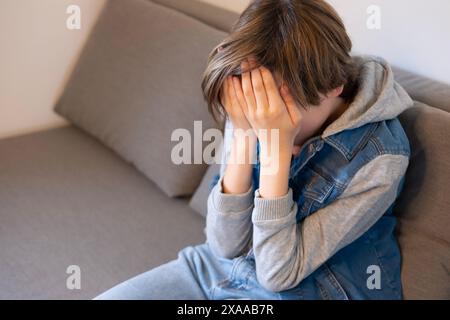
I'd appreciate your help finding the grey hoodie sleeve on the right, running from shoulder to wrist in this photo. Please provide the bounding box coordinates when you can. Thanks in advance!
[252,155,408,292]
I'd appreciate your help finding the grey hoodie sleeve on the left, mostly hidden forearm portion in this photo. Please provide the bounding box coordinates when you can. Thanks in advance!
[206,122,254,259]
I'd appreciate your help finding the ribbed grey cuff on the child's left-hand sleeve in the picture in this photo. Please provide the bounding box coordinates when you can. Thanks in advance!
[213,177,254,213]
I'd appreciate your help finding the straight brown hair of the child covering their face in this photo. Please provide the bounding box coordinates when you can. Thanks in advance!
[202,0,355,121]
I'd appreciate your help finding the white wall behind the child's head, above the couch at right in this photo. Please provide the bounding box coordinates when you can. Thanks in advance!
[202,0,450,84]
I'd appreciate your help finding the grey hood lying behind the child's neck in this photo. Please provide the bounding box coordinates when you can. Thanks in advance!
[322,56,413,138]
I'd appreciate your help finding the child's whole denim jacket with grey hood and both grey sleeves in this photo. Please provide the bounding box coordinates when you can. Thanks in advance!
[207,57,412,299]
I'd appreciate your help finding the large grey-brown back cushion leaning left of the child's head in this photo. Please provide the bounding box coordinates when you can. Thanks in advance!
[56,0,225,196]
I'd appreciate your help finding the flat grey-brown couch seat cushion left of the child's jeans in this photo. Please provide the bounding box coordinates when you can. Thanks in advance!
[0,127,205,300]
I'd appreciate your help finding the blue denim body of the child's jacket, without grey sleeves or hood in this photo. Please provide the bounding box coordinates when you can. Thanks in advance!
[253,119,410,299]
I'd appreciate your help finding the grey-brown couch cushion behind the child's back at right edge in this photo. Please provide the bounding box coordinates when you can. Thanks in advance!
[395,103,450,299]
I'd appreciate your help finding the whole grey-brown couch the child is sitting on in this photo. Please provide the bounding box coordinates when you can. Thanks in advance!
[0,0,450,299]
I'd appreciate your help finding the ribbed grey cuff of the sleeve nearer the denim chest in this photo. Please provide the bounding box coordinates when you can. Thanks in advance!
[252,188,294,221]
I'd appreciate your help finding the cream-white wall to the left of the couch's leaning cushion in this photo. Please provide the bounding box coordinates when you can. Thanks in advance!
[0,0,105,138]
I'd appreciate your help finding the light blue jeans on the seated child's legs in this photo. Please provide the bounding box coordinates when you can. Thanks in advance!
[95,243,300,300]
